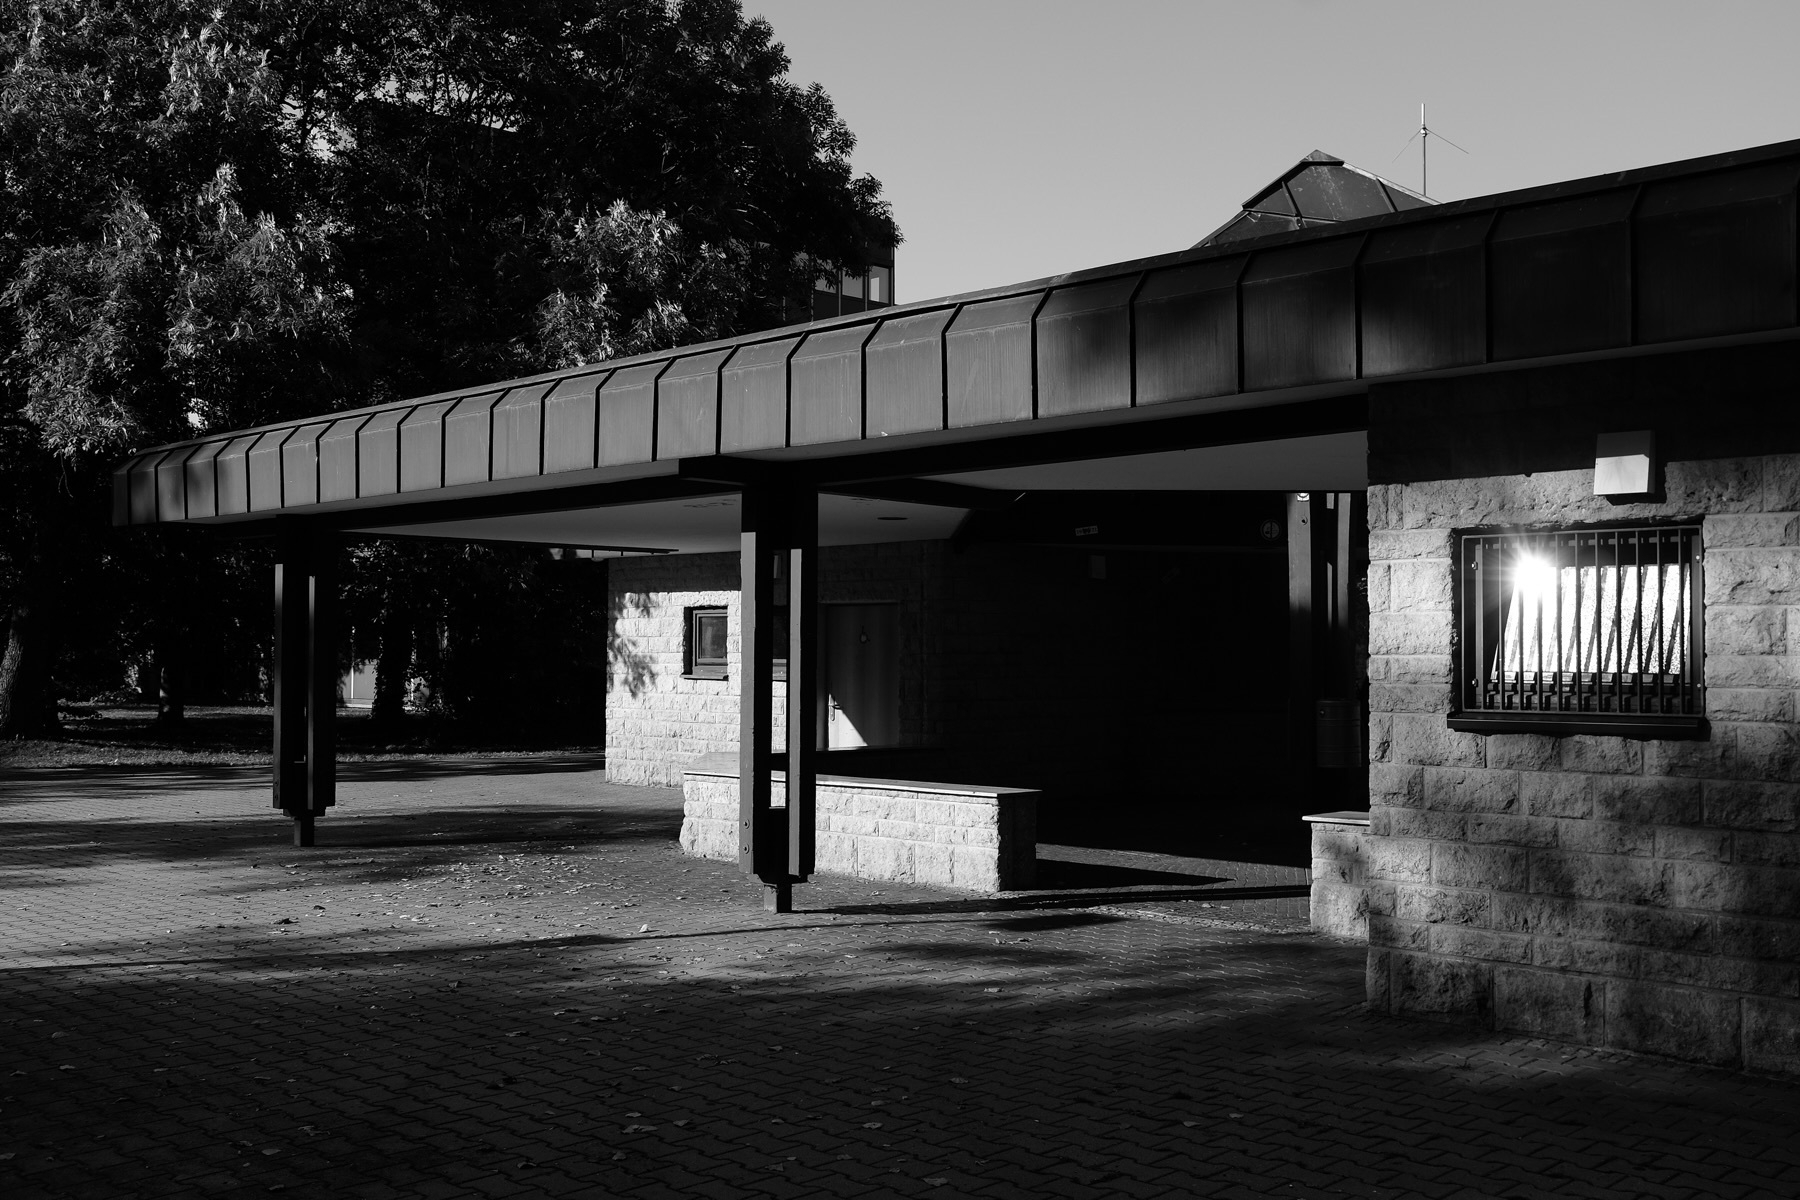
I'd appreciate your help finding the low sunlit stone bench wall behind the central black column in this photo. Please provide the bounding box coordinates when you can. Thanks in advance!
[680,754,1039,892]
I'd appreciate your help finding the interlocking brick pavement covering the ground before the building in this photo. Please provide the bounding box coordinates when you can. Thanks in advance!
[0,759,1800,1200]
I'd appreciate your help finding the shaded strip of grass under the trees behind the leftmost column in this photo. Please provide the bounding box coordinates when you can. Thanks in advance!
[0,703,603,768]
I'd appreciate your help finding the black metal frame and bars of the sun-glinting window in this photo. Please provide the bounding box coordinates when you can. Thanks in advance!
[1445,518,1710,739]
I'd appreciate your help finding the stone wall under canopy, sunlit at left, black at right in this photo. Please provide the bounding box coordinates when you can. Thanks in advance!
[607,542,1307,858]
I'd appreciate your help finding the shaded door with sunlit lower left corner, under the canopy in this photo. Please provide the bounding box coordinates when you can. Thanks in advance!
[819,604,900,750]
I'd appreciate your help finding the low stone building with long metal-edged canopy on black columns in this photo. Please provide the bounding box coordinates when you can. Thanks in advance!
[115,142,1800,1072]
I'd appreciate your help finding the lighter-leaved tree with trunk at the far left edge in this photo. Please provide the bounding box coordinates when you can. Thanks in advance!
[0,2,347,734]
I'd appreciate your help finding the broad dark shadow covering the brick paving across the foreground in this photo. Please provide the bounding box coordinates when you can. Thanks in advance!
[0,888,1800,1196]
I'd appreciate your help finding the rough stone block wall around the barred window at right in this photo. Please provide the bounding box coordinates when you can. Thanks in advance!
[1363,455,1800,1072]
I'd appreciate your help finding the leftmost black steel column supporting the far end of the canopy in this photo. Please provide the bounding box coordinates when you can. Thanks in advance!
[274,533,337,846]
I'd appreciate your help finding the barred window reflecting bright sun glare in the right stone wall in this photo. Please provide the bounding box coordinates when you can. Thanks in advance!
[1451,525,1705,738]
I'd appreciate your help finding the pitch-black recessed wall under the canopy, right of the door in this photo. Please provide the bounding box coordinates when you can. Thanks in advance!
[932,545,1300,851]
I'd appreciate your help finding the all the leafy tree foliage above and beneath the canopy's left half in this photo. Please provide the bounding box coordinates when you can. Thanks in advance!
[0,0,898,730]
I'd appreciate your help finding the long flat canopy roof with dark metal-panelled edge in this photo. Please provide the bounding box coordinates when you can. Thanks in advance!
[113,134,1800,549]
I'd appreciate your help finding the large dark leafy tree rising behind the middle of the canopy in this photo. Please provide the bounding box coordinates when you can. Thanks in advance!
[300,0,898,720]
